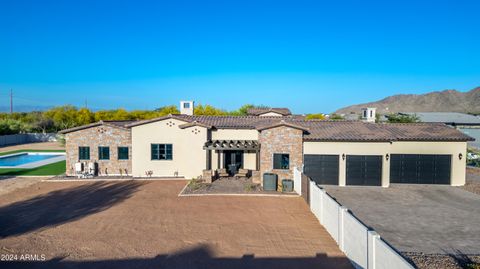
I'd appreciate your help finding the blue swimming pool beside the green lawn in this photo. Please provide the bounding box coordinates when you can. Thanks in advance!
[0,152,65,168]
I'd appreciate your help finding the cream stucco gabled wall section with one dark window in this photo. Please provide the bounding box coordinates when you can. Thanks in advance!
[132,119,208,178]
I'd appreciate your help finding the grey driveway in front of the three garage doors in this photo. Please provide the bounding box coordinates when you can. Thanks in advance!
[325,184,480,254]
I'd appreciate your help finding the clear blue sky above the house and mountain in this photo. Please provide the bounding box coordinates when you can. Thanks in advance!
[0,0,480,113]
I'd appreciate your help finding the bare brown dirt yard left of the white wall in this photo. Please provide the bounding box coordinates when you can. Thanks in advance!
[0,180,352,269]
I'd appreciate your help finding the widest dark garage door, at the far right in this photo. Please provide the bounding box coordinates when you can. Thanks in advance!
[390,154,452,184]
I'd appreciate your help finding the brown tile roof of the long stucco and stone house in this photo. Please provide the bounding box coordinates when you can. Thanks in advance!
[61,115,473,142]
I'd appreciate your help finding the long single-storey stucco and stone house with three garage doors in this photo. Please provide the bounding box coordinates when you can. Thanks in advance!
[62,103,472,187]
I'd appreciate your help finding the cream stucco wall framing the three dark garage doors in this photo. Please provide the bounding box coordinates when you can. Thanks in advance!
[303,142,467,184]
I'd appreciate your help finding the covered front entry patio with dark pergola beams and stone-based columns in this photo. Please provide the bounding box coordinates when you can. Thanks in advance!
[203,140,260,181]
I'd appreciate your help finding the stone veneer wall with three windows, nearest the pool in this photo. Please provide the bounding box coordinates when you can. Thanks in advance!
[65,125,132,176]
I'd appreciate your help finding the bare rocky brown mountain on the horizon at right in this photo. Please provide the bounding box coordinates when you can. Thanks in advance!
[335,87,480,114]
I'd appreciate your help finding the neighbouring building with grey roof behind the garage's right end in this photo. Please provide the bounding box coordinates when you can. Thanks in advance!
[399,112,480,148]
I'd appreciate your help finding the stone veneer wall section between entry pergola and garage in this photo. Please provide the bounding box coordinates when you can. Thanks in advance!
[259,126,303,190]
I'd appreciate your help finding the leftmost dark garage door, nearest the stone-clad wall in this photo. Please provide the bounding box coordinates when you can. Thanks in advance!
[303,154,340,185]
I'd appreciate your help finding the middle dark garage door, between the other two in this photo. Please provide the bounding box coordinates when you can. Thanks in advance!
[346,155,383,186]
